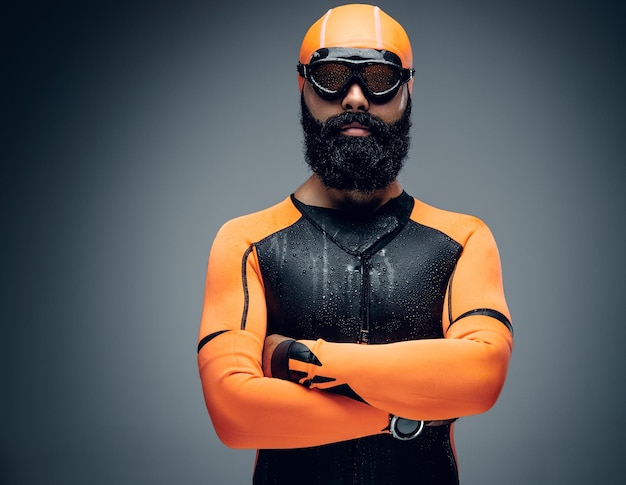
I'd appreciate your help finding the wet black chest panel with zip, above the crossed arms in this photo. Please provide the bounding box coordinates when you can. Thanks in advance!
[251,193,462,344]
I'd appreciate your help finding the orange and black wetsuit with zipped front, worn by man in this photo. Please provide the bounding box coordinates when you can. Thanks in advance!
[198,193,513,484]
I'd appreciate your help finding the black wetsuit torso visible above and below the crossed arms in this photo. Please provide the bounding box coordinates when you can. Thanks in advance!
[253,193,462,485]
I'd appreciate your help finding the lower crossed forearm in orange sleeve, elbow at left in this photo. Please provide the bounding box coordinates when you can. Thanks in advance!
[199,330,388,448]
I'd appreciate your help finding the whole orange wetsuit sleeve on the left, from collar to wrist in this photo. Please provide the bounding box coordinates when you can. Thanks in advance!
[198,202,388,448]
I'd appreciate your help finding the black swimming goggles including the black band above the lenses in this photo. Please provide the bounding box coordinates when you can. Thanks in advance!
[298,47,415,103]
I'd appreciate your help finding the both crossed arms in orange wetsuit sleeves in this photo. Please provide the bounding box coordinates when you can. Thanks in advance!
[198,217,512,448]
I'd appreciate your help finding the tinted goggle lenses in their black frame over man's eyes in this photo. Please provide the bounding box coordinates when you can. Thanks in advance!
[301,62,412,100]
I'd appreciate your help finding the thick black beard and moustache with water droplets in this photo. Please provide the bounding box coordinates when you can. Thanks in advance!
[300,94,411,193]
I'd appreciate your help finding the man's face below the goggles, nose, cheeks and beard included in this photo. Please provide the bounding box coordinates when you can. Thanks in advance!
[301,82,411,193]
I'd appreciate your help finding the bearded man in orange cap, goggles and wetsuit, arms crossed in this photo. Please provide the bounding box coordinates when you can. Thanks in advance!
[198,4,513,485]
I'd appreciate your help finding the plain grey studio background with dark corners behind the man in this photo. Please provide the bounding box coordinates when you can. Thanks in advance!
[0,0,626,485]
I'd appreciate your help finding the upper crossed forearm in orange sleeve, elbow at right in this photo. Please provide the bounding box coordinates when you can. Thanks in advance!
[268,317,512,420]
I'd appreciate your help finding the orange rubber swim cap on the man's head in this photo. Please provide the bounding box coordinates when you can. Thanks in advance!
[298,4,413,91]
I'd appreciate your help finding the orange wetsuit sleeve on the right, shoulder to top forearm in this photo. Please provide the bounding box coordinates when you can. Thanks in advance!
[280,219,513,420]
